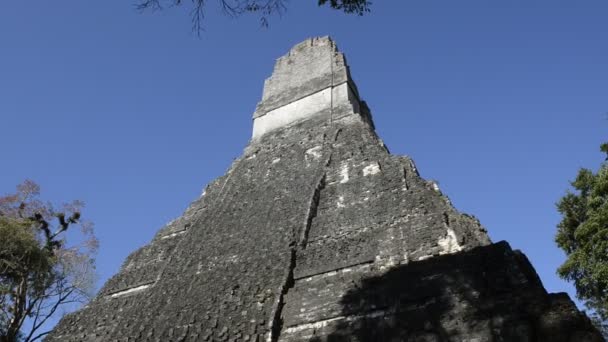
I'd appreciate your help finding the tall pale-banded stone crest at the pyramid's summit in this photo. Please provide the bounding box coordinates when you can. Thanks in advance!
[252,37,371,140]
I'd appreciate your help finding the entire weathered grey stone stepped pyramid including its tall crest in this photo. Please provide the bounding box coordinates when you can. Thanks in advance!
[47,37,602,342]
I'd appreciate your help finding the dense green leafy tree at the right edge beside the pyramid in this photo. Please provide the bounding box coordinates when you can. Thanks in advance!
[555,143,608,332]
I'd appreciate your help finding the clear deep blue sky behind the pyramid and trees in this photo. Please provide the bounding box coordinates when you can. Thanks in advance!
[0,0,608,320]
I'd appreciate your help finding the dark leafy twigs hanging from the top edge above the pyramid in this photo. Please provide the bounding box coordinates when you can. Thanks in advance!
[136,0,372,33]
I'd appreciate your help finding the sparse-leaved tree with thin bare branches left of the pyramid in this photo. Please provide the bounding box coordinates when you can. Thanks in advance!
[0,180,97,342]
